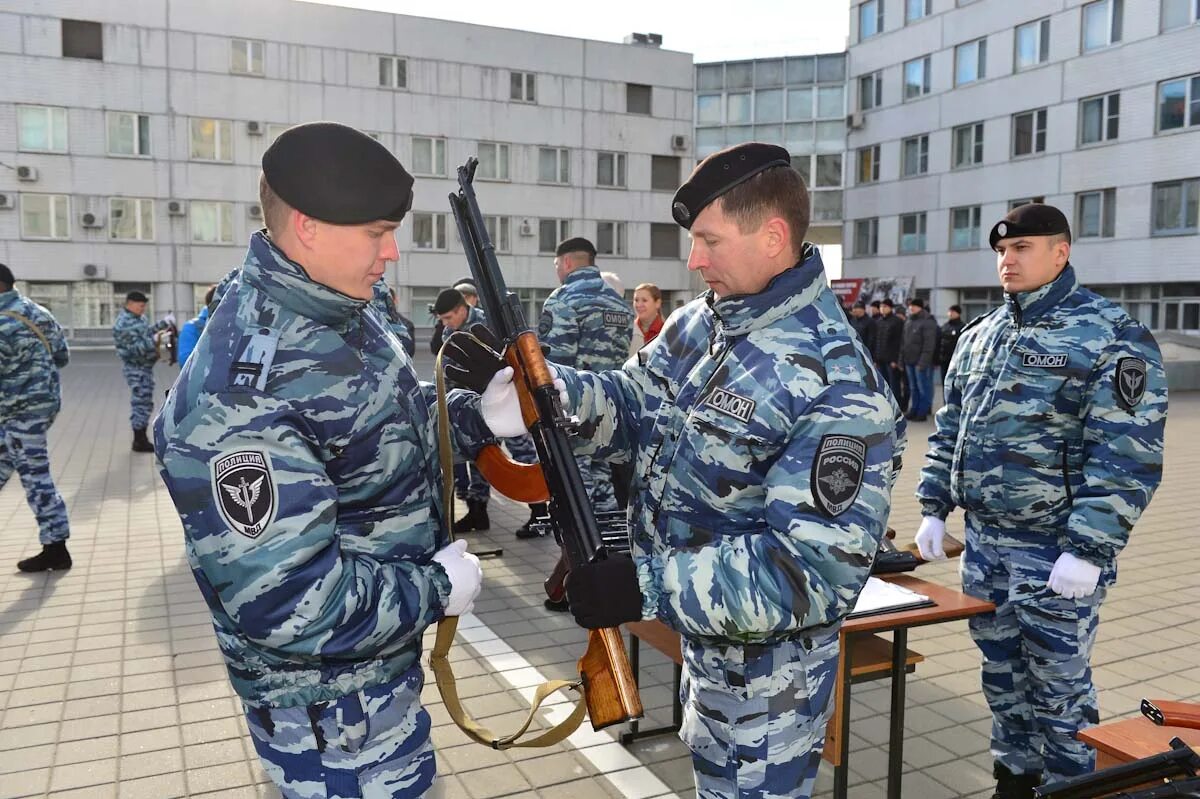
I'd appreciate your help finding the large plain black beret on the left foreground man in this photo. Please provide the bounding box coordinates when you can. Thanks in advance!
[263,122,413,224]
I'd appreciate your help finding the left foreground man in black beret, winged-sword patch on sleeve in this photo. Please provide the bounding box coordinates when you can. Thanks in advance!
[155,122,493,799]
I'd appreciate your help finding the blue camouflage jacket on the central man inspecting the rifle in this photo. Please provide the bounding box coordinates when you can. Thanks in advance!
[559,245,904,643]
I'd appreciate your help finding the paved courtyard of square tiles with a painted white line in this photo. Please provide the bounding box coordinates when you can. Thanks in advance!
[0,352,1200,799]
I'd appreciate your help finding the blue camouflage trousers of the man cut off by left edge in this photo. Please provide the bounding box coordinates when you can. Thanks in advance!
[0,416,71,545]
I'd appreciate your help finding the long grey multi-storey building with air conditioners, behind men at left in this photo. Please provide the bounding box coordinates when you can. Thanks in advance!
[0,0,694,340]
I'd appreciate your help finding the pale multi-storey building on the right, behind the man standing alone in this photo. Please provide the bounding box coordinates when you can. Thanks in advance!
[844,0,1200,332]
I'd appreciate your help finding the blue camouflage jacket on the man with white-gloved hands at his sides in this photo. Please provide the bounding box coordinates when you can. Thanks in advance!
[917,266,1166,573]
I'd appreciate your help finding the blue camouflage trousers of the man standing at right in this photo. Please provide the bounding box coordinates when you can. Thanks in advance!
[960,516,1106,782]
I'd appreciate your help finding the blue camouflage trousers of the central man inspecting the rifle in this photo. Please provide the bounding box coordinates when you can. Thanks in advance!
[679,630,838,799]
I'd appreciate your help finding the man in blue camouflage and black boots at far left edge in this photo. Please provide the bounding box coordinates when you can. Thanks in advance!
[0,264,71,571]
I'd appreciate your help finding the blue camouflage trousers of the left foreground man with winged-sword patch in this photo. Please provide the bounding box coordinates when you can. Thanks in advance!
[245,666,437,799]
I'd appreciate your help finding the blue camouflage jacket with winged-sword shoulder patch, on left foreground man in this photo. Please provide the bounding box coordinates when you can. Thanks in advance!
[155,233,493,707]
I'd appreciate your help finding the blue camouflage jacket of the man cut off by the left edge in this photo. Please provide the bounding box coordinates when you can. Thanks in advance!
[0,289,71,425]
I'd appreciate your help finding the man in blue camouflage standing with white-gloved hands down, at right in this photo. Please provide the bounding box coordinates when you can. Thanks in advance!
[917,203,1166,799]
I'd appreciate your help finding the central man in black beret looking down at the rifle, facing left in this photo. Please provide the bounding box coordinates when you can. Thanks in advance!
[451,143,905,799]
